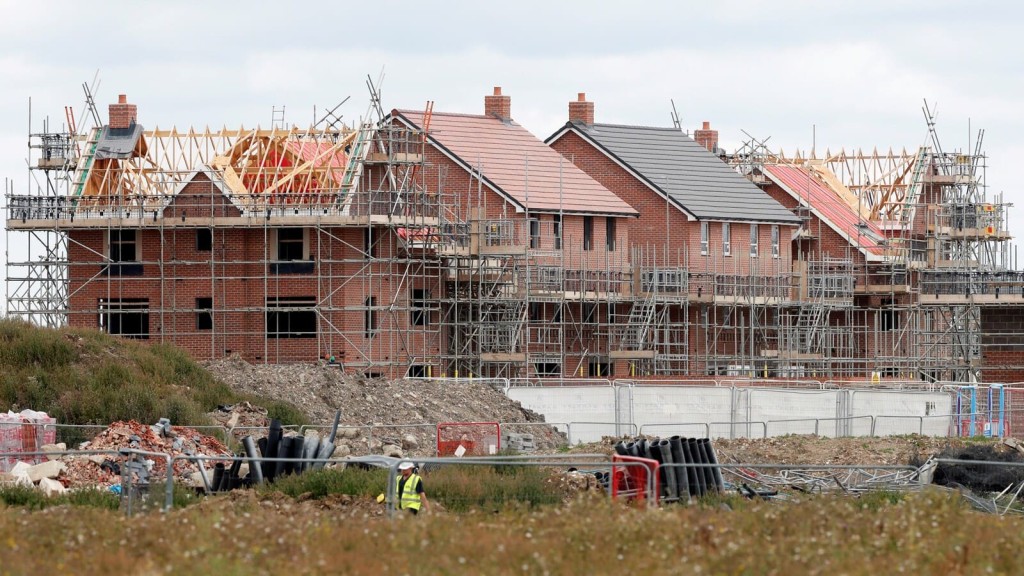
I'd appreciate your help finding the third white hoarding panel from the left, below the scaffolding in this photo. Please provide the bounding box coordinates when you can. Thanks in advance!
[737,388,839,437]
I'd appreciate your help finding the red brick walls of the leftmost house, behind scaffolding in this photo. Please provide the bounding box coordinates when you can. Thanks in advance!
[69,219,437,372]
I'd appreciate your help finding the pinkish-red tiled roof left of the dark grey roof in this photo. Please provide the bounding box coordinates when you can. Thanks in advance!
[392,110,637,216]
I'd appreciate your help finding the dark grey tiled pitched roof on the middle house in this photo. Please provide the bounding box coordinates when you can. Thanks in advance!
[547,122,799,223]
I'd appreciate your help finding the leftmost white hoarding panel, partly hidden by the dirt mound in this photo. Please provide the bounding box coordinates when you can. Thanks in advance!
[507,385,610,444]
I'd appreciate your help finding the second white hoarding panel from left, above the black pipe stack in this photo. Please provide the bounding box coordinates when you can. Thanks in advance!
[624,384,733,437]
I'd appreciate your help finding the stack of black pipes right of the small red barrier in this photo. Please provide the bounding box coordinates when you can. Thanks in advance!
[615,436,725,502]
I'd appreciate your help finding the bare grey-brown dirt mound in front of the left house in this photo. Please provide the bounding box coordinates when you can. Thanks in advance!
[204,357,564,456]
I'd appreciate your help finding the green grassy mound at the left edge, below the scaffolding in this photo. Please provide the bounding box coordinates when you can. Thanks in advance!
[0,319,308,430]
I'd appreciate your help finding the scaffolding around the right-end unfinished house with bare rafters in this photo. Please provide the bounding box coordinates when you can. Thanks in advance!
[745,104,1024,382]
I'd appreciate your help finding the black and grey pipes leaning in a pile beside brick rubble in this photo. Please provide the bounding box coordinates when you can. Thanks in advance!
[209,410,341,492]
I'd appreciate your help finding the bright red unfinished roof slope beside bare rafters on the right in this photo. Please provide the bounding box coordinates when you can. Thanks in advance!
[763,164,885,256]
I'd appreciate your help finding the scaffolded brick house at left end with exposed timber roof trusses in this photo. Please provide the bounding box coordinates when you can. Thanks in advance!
[6,84,451,375]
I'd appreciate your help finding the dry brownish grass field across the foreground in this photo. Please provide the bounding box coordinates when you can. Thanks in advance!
[0,483,1024,575]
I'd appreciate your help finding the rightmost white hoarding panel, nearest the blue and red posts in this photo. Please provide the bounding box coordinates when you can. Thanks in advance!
[848,389,953,437]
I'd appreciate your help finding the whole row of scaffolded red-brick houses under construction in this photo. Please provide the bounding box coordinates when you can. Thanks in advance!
[5,81,1024,383]
